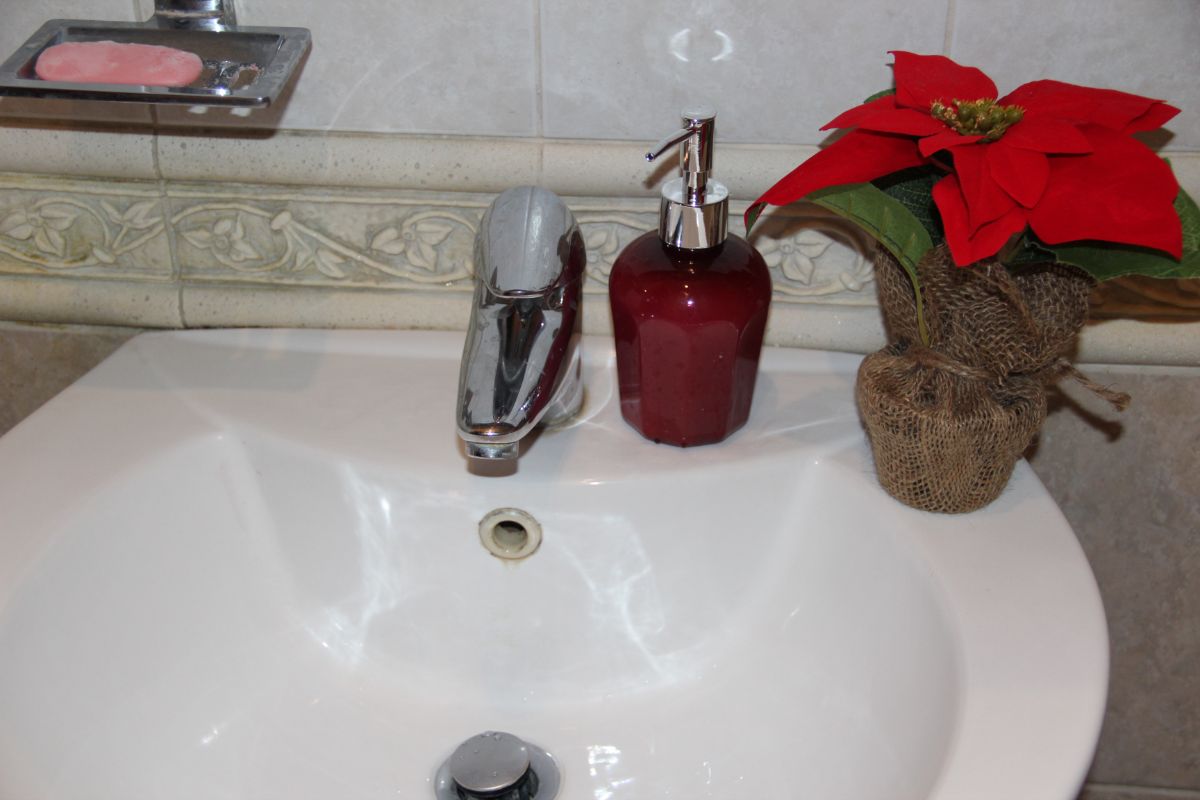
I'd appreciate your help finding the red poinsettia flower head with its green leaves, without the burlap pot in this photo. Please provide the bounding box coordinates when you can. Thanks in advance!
[745,52,1200,335]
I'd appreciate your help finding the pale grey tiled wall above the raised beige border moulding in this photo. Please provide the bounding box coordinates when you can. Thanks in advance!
[9,0,1200,151]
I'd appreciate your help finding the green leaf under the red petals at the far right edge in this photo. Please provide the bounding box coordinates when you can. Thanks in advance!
[1044,188,1200,281]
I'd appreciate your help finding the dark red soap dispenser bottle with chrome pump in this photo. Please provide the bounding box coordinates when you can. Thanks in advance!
[608,108,770,446]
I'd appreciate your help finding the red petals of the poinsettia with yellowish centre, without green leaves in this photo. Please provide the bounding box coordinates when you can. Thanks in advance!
[748,52,1182,266]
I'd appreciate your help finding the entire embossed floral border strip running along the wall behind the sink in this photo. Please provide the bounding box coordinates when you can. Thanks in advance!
[0,174,1200,320]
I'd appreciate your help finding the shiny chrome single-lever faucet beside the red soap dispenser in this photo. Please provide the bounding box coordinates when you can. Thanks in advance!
[458,186,587,459]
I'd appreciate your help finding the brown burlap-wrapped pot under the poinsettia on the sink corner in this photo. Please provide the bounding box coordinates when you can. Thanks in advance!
[856,247,1092,513]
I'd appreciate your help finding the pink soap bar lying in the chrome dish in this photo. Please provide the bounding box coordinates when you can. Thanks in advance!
[34,42,204,86]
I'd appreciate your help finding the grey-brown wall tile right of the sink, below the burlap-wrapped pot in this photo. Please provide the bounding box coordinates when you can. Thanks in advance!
[1031,367,1200,796]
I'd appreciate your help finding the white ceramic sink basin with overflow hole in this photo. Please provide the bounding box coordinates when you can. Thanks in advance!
[0,330,1108,800]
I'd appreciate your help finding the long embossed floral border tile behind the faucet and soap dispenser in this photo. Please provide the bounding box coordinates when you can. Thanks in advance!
[168,185,874,305]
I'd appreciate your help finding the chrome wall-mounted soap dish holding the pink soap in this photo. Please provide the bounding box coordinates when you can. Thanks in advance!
[0,0,312,108]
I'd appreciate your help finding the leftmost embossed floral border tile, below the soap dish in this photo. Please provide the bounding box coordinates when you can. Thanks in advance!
[0,176,173,281]
